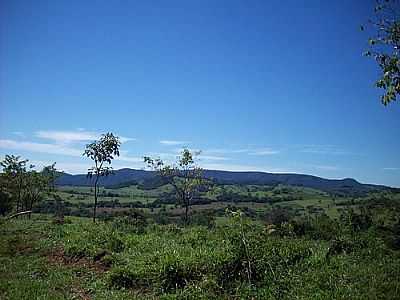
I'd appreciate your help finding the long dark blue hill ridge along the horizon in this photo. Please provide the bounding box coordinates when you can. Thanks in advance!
[56,169,389,195]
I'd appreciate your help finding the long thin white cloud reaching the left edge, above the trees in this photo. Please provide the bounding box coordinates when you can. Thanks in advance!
[0,140,83,156]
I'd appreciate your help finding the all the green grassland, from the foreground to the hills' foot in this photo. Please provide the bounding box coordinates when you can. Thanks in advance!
[0,185,400,300]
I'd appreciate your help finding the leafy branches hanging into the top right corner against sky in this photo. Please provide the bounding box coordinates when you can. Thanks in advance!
[361,0,400,105]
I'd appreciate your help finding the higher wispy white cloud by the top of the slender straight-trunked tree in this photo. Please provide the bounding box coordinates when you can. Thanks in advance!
[35,128,135,144]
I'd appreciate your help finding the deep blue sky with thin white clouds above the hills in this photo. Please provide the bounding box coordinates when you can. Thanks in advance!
[0,0,400,187]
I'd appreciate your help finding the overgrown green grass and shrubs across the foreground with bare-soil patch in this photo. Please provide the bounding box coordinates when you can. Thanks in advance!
[0,216,400,299]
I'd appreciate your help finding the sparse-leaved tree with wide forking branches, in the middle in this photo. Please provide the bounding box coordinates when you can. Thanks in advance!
[144,149,206,224]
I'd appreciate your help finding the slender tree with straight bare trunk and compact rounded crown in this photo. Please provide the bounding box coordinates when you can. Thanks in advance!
[83,132,121,222]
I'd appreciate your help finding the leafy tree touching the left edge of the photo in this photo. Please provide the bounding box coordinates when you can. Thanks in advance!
[0,155,28,213]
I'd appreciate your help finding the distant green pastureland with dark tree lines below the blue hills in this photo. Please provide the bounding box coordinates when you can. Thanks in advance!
[45,185,348,218]
